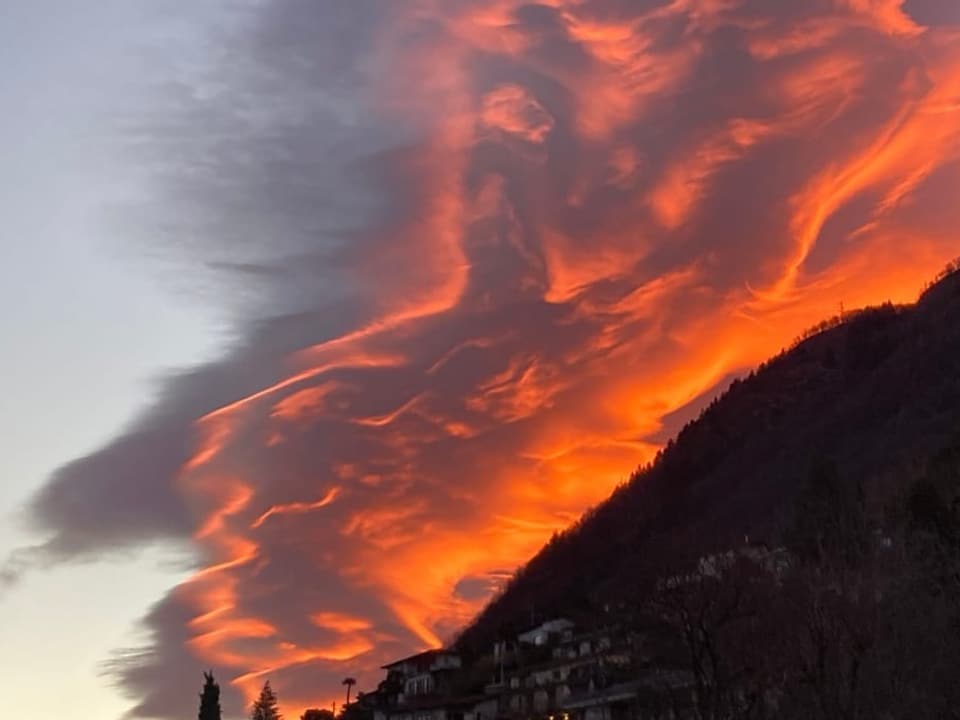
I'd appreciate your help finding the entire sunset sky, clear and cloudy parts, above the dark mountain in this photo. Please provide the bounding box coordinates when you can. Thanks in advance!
[0,0,960,720]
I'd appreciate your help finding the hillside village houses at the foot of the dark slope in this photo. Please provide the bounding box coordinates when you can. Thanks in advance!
[348,545,787,720]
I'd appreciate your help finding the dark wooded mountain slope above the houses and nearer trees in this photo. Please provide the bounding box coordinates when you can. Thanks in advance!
[457,266,960,655]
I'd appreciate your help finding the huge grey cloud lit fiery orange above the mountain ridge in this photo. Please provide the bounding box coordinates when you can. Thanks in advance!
[9,0,960,717]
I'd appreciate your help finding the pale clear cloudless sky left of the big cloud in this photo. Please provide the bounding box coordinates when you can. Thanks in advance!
[0,0,224,720]
